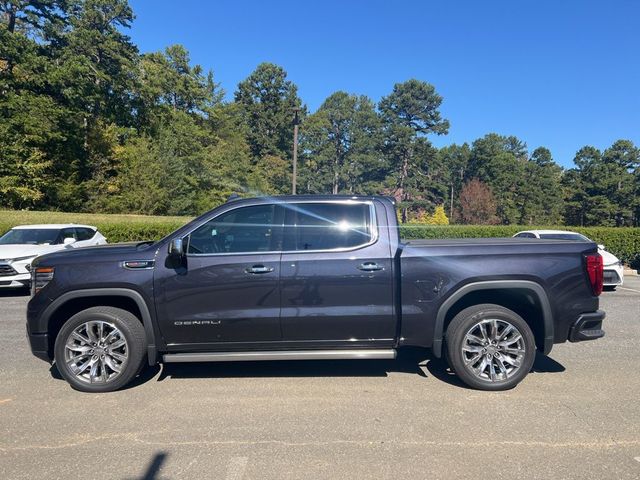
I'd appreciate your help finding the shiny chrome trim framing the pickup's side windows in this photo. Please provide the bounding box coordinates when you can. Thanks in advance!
[182,199,380,257]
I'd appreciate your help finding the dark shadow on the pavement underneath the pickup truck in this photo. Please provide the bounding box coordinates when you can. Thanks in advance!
[152,348,565,388]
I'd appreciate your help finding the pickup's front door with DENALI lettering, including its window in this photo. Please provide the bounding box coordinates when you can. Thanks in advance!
[155,205,282,350]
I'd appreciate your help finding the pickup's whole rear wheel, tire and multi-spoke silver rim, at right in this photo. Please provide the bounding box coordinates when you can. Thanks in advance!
[446,304,536,390]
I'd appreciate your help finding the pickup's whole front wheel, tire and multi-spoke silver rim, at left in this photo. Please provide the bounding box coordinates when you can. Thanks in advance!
[54,307,146,392]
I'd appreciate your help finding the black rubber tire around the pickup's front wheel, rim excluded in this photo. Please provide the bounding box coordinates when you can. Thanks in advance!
[54,307,147,393]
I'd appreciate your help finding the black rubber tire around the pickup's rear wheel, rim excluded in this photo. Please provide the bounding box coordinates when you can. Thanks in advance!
[446,304,536,391]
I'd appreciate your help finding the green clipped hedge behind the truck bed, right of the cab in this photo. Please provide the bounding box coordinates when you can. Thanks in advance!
[400,224,640,269]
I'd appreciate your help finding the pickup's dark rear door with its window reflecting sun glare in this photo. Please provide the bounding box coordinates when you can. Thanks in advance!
[281,201,396,347]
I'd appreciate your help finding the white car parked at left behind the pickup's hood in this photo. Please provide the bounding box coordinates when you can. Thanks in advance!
[0,223,107,288]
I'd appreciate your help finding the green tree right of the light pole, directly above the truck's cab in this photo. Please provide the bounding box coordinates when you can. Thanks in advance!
[301,92,384,194]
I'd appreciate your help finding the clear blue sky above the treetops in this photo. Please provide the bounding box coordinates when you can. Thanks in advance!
[129,0,640,166]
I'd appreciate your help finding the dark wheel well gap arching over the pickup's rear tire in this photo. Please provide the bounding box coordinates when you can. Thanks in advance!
[443,288,545,350]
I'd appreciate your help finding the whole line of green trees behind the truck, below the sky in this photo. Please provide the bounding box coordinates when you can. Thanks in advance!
[0,0,640,231]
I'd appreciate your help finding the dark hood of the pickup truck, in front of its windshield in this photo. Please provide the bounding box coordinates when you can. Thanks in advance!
[33,243,155,266]
